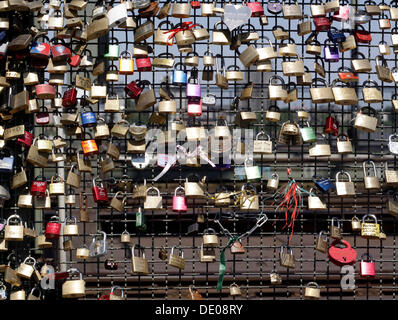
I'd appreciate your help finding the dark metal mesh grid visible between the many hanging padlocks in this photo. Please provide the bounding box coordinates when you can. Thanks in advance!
[1,1,396,299]
